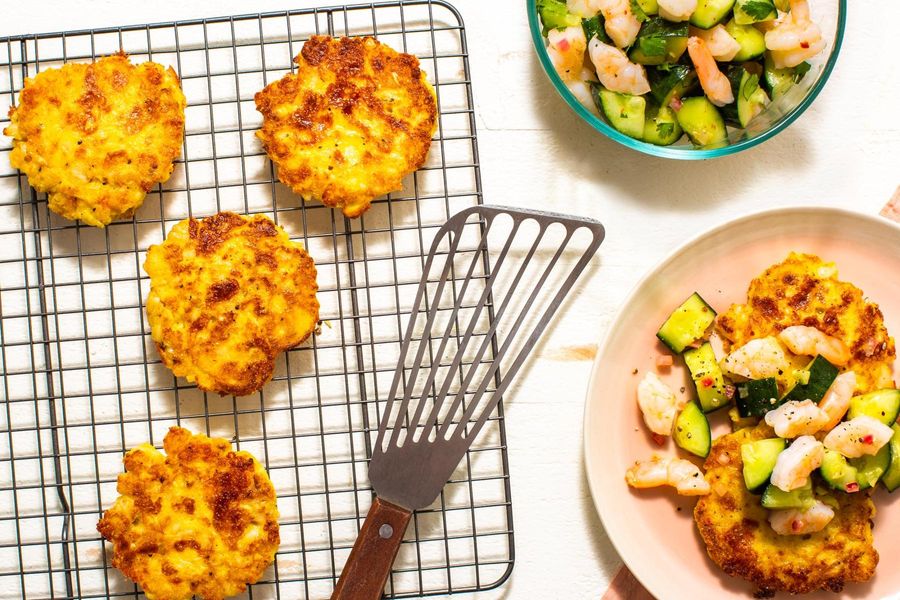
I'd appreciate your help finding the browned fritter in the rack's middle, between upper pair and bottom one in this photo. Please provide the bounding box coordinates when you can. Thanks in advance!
[144,212,319,396]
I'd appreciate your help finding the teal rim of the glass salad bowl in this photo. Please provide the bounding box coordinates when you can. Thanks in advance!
[525,0,847,160]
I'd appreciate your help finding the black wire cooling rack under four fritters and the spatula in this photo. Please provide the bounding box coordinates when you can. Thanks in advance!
[0,0,514,598]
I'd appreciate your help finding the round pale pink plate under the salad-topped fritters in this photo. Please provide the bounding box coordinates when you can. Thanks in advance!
[584,208,900,600]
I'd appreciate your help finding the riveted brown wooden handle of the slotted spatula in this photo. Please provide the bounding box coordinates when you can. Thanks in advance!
[331,498,412,600]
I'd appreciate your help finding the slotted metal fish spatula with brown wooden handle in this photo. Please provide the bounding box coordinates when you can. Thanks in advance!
[331,206,604,600]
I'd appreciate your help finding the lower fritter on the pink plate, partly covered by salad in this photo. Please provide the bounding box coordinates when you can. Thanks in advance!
[694,425,878,597]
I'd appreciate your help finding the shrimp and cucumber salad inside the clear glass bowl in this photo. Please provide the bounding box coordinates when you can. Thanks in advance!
[537,0,825,147]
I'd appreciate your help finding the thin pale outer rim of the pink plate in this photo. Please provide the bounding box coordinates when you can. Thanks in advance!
[582,205,900,598]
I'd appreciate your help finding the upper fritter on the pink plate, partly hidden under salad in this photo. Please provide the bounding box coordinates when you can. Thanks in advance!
[716,252,897,393]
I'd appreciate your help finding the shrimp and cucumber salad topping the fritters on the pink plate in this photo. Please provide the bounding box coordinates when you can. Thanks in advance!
[625,293,900,535]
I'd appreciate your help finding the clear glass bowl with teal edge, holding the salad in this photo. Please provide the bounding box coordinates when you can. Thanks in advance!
[525,0,847,160]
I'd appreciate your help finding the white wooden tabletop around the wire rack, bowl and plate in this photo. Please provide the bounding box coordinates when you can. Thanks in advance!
[0,0,900,600]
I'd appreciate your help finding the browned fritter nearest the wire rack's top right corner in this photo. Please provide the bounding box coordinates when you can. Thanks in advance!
[256,35,437,217]
